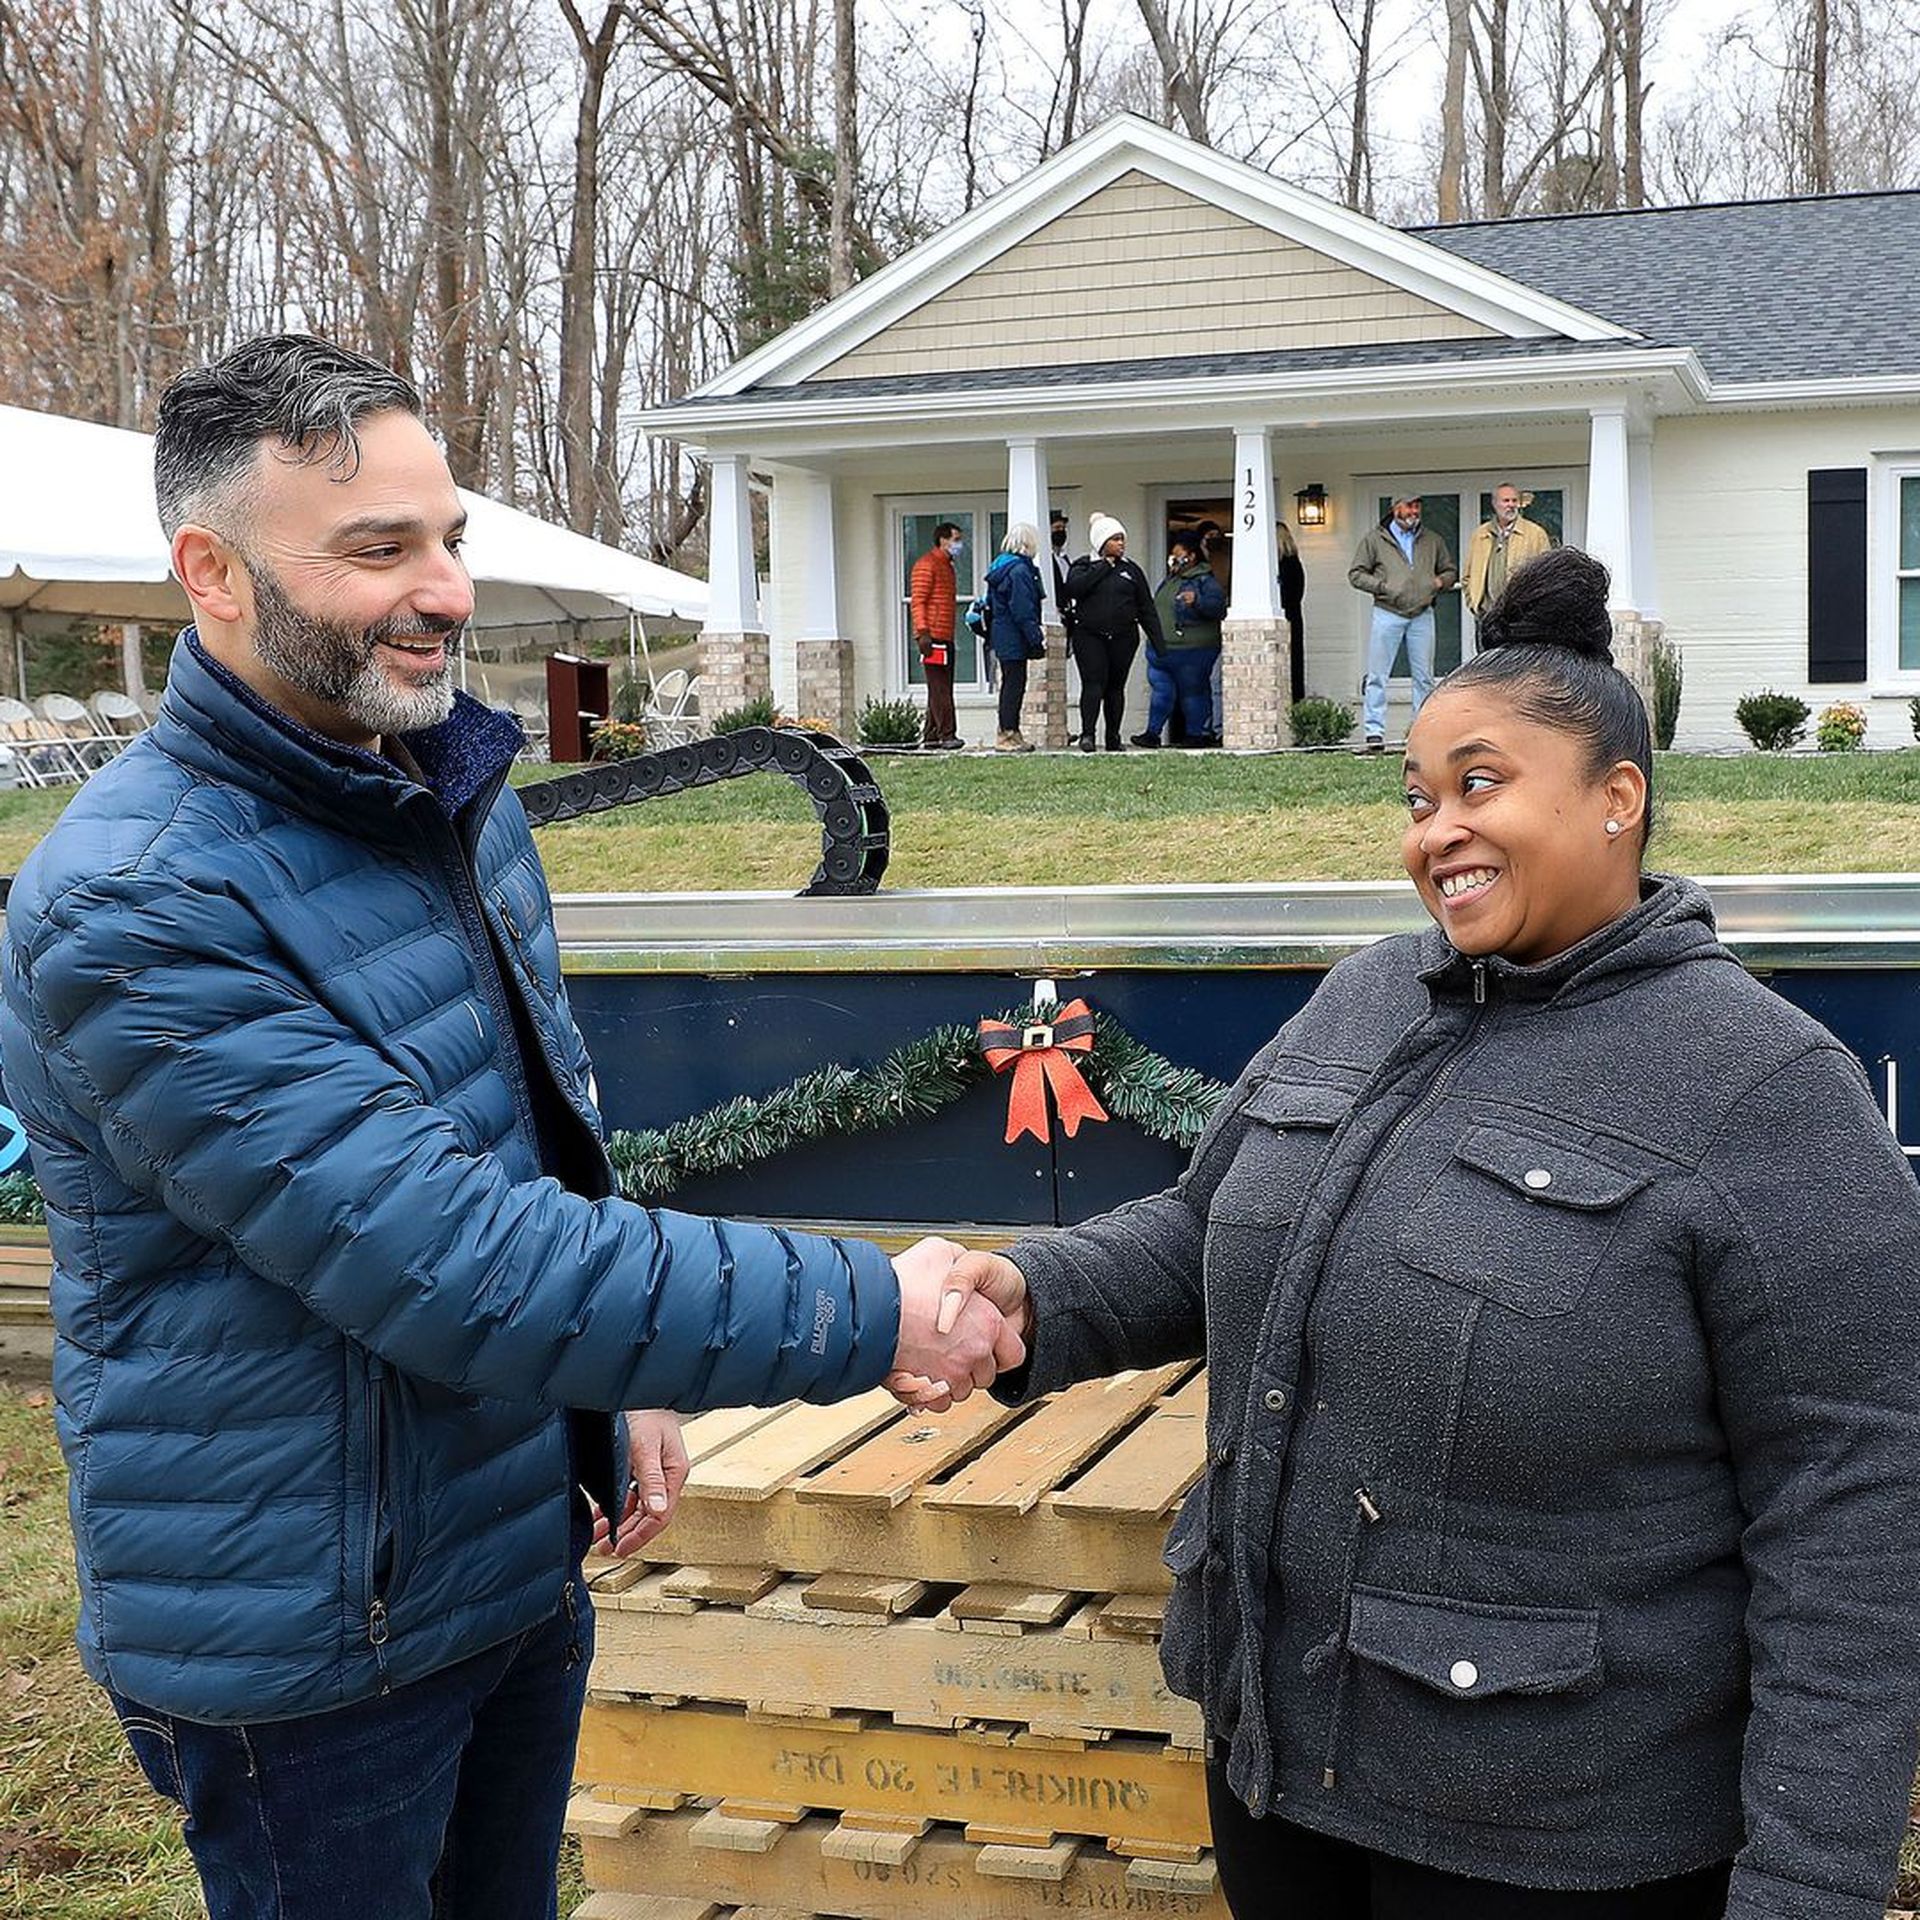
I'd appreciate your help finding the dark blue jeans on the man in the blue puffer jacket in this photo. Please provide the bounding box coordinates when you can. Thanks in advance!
[109,1578,593,1920]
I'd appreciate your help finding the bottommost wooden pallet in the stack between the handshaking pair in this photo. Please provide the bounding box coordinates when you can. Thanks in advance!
[568,1795,1227,1920]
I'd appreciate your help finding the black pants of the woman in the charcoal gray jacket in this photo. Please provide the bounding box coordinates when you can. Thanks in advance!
[1206,1761,1732,1920]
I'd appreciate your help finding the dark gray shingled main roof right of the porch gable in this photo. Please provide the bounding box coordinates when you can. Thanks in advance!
[1409,192,1920,384]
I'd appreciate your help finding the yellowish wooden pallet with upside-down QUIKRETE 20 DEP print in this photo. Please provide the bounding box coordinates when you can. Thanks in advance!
[574,1697,1210,1853]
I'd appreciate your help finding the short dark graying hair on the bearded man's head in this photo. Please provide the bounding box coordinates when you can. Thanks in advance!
[154,334,420,541]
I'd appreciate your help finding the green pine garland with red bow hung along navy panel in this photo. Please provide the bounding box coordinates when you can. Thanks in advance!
[0,1006,1227,1227]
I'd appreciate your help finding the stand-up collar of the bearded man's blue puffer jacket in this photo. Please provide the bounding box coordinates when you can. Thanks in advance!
[154,628,522,837]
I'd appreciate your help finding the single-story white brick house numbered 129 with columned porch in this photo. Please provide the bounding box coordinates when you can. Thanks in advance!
[643,117,1920,747]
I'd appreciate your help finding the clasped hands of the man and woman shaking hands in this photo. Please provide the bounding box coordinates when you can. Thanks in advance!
[885,1238,1033,1413]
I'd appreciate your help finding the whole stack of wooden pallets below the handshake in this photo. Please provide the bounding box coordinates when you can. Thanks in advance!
[570,1365,1225,1920]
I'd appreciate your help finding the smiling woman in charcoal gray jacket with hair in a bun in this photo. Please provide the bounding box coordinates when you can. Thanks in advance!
[906,549,1920,1920]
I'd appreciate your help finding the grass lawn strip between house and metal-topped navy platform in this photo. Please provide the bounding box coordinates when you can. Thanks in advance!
[0,749,1920,893]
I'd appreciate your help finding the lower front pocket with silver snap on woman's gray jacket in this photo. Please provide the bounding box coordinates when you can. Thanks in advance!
[1338,1586,1611,1828]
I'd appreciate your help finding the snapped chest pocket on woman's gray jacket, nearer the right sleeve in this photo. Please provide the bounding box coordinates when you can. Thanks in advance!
[1400,1125,1653,1317]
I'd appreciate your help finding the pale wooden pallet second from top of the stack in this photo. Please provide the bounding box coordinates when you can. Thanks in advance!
[593,1563,1200,1745]
